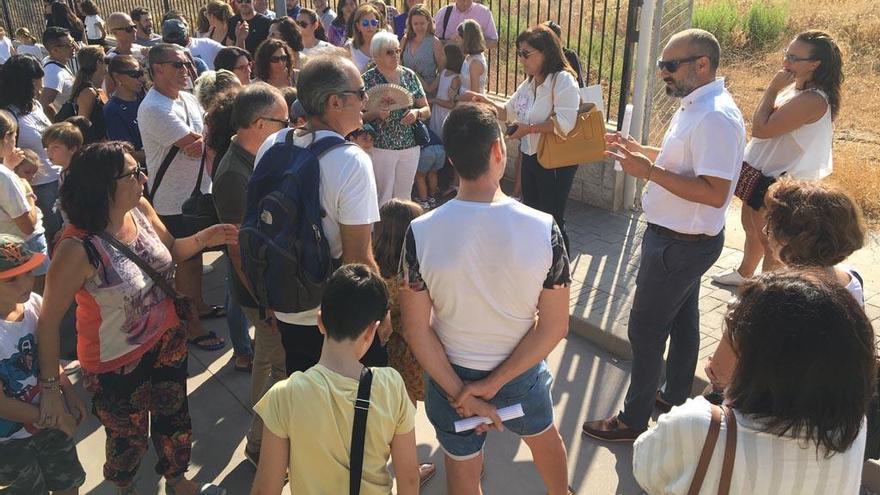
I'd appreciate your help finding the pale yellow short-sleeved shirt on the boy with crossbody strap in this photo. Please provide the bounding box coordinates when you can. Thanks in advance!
[254,364,415,495]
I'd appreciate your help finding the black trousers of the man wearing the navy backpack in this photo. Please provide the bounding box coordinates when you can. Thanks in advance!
[278,320,388,376]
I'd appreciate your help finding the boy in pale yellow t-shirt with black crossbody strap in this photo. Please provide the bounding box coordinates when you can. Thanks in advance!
[251,264,419,495]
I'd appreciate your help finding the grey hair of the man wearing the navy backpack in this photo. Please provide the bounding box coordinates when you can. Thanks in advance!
[296,55,357,117]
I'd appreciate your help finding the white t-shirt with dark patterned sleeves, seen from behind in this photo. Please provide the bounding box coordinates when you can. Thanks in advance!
[400,198,571,371]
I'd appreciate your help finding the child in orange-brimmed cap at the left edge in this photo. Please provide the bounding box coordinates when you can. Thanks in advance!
[0,234,86,495]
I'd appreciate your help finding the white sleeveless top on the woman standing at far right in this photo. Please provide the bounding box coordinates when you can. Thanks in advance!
[744,86,832,180]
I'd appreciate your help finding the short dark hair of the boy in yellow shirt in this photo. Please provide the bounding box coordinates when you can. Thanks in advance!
[321,263,388,341]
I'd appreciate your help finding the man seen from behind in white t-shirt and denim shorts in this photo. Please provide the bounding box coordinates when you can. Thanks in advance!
[400,105,571,495]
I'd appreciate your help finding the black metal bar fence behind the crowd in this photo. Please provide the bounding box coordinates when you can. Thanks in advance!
[0,0,632,121]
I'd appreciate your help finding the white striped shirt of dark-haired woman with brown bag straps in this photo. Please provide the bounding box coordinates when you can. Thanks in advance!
[633,397,867,495]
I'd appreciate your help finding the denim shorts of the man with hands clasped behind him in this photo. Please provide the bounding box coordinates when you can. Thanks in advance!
[425,361,553,461]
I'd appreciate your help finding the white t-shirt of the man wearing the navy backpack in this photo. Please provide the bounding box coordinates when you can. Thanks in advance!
[254,129,379,325]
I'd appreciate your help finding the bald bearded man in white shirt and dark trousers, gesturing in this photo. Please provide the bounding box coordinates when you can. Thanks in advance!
[583,29,745,441]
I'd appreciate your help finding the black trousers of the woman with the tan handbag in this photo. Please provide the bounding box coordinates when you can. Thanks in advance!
[522,153,577,256]
